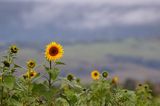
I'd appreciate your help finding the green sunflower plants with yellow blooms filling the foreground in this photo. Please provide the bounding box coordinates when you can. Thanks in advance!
[0,42,160,106]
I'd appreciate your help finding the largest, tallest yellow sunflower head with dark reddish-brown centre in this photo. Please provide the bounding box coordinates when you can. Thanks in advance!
[45,42,64,61]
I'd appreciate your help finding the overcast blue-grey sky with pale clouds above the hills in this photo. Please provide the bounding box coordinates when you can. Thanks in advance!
[0,0,160,43]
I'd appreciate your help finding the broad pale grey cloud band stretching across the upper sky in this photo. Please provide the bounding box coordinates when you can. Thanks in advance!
[19,0,160,29]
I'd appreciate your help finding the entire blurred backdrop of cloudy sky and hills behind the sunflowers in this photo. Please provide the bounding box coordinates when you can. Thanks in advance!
[0,0,160,91]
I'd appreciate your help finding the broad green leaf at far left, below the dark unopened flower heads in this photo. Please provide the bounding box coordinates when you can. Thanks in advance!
[4,75,16,89]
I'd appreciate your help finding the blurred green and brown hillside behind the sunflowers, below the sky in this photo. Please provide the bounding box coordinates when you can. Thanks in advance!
[0,38,160,81]
